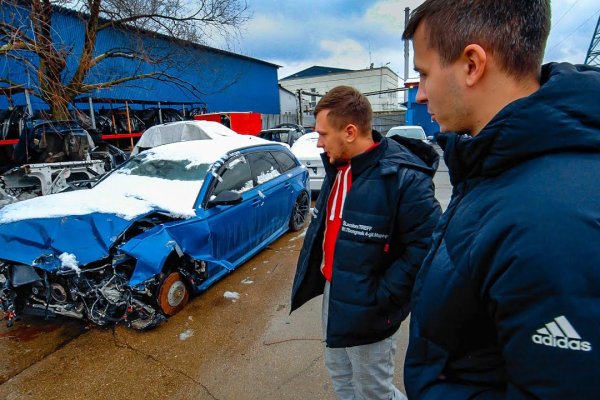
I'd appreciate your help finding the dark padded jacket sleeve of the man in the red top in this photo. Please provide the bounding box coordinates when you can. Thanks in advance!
[377,169,441,317]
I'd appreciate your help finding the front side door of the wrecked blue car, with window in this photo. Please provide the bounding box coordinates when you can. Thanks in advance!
[206,154,262,264]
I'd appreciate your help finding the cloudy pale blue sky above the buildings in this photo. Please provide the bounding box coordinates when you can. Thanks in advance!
[234,0,600,79]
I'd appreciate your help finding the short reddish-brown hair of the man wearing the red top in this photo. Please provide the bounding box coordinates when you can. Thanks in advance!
[314,86,373,134]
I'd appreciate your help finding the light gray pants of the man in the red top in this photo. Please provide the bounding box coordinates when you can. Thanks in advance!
[323,282,406,400]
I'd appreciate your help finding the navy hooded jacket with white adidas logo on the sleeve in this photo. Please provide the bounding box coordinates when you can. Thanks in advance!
[404,64,600,400]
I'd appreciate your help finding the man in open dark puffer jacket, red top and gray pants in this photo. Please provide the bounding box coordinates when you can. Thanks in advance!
[292,86,440,400]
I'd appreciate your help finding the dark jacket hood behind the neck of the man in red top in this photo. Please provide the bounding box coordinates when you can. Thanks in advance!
[321,131,439,176]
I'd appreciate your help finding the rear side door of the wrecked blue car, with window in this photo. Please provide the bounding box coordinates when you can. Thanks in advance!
[247,151,293,245]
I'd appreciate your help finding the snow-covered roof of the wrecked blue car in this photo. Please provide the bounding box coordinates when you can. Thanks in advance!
[141,135,287,164]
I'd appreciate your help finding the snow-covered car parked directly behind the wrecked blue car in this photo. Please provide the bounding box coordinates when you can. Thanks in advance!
[131,121,241,156]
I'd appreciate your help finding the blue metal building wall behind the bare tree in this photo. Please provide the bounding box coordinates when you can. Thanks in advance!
[0,3,280,114]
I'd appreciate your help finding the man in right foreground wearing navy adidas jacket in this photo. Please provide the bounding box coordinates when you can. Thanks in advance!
[404,0,600,400]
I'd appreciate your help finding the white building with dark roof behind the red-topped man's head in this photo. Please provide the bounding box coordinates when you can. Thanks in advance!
[279,66,400,114]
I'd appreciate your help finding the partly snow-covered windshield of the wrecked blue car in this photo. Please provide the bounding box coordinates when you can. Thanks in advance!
[115,153,210,181]
